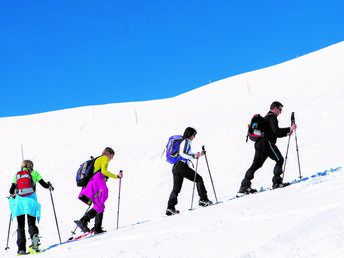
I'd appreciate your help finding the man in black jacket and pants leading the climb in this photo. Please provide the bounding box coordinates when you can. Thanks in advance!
[239,101,297,194]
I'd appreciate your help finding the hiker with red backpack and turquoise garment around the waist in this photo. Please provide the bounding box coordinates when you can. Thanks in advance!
[9,160,54,255]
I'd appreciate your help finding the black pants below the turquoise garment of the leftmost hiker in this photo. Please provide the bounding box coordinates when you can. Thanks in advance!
[17,215,38,251]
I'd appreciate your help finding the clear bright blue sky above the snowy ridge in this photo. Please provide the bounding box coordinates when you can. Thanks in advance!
[0,0,344,117]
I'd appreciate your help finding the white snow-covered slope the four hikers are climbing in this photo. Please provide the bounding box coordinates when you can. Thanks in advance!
[0,42,344,258]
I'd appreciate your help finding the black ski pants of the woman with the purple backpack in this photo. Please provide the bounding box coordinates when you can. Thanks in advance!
[167,161,208,208]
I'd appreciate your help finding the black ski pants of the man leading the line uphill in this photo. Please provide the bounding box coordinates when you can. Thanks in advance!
[241,139,284,188]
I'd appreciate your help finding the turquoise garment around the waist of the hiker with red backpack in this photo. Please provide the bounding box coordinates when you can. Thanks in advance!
[9,193,41,223]
